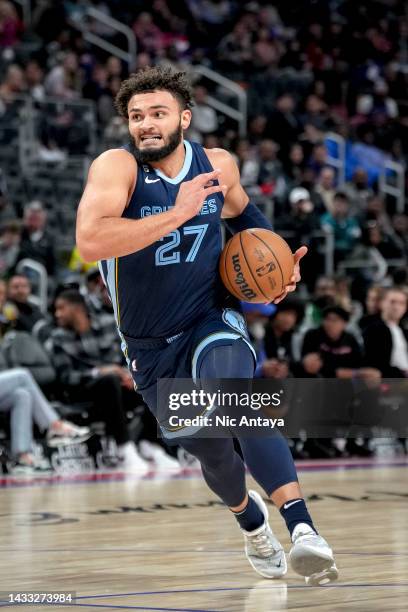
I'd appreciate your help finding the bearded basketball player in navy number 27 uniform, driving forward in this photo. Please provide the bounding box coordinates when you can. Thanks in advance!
[77,67,338,585]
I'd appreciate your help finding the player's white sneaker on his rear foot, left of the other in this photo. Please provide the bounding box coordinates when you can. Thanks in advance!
[242,491,287,578]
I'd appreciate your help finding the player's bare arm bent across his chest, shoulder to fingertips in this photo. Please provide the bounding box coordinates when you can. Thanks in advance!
[76,149,223,261]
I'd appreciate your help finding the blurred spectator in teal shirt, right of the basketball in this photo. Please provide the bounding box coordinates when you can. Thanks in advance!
[321,191,361,263]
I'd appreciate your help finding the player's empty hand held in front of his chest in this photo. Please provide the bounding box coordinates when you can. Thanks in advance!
[174,169,227,223]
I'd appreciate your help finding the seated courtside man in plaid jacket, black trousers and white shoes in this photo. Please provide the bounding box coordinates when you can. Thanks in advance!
[46,289,148,474]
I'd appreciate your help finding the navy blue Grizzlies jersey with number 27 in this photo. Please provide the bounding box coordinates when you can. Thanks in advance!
[99,141,224,338]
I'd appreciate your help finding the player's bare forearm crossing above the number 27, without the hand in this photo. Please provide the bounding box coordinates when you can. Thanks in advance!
[76,209,185,261]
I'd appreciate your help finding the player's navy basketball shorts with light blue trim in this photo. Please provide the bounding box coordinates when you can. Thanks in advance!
[124,308,256,438]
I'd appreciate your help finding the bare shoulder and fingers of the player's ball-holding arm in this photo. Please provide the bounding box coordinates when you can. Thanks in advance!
[206,149,307,304]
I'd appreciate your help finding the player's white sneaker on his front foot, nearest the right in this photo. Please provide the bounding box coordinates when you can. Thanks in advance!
[289,523,339,586]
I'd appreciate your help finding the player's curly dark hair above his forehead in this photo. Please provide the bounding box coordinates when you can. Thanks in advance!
[115,66,194,119]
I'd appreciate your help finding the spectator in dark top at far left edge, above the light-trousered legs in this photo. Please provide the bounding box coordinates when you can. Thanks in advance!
[7,274,45,332]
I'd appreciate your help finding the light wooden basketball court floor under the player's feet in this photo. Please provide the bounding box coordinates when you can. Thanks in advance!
[0,458,408,612]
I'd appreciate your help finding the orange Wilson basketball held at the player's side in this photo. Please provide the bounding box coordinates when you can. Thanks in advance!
[219,228,294,304]
